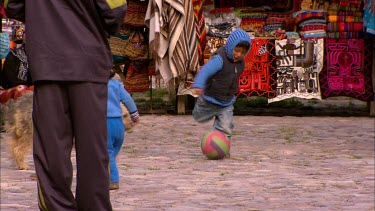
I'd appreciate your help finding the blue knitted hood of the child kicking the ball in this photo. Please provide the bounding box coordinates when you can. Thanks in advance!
[225,29,251,59]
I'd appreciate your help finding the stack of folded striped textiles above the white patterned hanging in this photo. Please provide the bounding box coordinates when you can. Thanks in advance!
[293,10,327,39]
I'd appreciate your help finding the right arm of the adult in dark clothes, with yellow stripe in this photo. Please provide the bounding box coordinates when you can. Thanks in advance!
[96,0,127,35]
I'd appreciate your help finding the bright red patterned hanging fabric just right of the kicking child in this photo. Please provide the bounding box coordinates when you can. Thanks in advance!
[237,38,276,98]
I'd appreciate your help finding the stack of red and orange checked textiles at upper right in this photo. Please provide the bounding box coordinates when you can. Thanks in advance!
[327,0,364,39]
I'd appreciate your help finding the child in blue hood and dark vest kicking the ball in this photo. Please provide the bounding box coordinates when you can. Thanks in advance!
[192,29,251,139]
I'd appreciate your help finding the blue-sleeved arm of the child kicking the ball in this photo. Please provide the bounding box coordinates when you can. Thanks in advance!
[192,55,223,95]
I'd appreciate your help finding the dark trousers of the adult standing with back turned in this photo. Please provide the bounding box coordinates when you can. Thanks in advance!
[33,82,112,211]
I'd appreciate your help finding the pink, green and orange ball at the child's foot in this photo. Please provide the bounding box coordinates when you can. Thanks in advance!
[201,130,230,160]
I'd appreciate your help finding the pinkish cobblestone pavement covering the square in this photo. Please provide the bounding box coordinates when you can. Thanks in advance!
[1,115,375,211]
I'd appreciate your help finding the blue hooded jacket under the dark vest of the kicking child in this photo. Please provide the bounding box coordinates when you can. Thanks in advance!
[192,29,251,106]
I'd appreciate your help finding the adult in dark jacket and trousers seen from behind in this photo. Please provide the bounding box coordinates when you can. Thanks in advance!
[4,0,127,211]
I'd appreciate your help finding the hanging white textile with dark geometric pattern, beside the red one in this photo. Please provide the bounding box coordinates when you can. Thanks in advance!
[268,39,324,103]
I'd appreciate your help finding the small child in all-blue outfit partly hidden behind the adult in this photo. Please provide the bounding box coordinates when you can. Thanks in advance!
[107,71,139,190]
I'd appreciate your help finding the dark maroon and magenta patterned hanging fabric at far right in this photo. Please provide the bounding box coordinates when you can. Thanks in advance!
[320,39,373,101]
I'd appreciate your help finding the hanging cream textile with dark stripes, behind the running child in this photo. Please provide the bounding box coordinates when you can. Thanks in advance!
[145,0,199,83]
